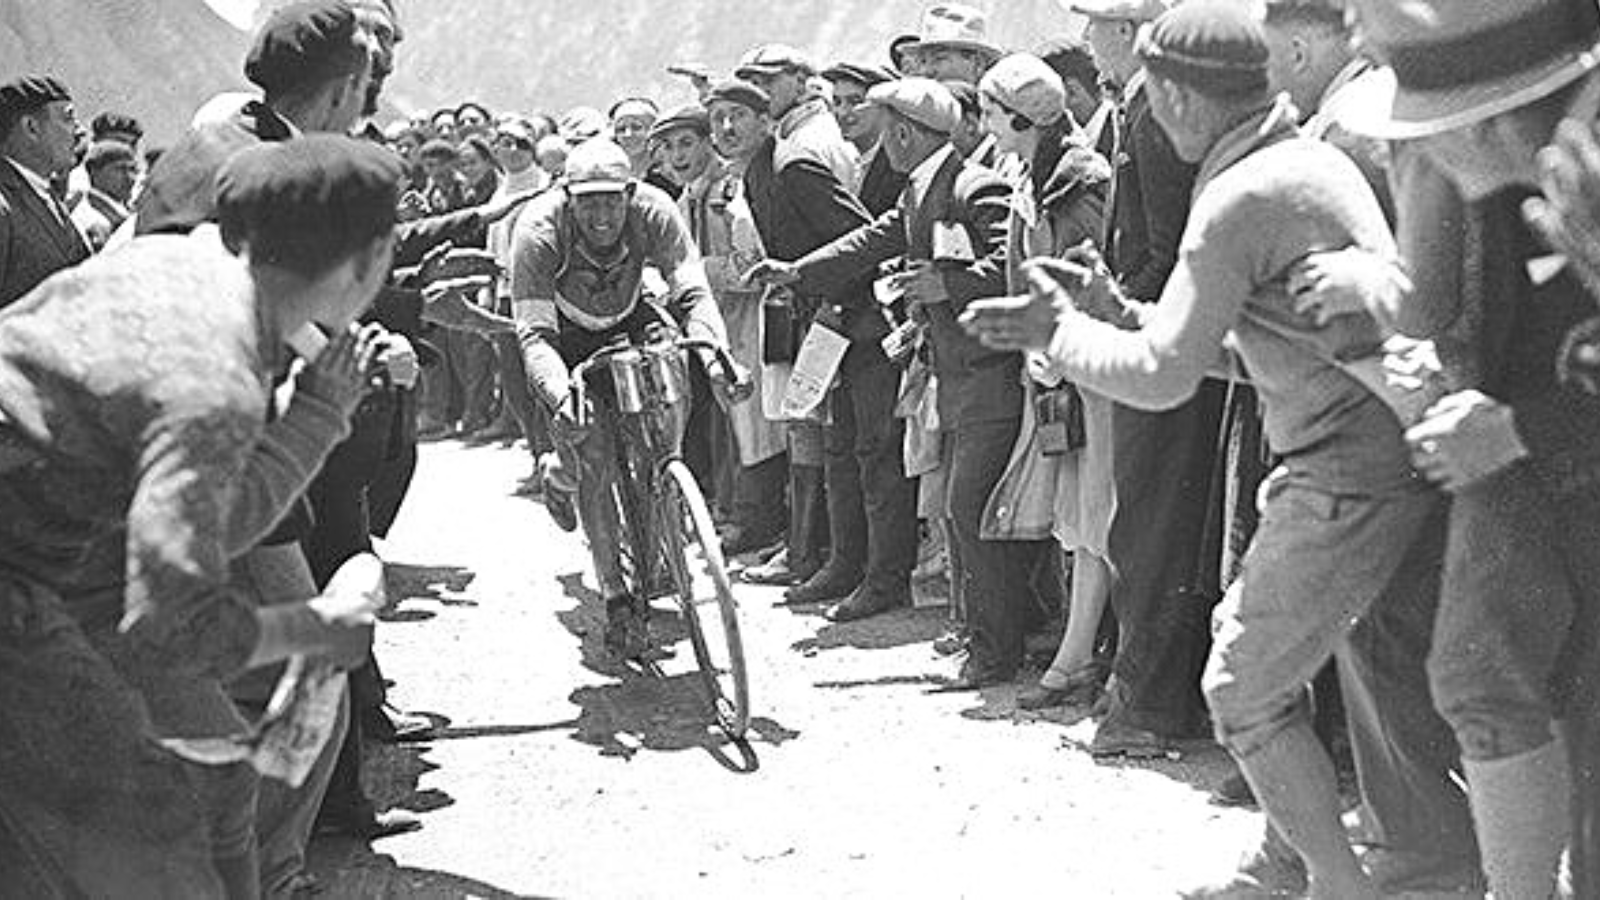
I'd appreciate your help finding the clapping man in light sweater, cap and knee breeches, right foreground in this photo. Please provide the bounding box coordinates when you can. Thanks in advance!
[968,0,1470,898]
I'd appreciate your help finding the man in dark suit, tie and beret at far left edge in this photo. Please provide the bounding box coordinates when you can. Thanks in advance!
[0,75,90,309]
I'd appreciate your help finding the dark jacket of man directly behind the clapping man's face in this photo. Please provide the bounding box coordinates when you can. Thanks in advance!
[1106,90,1195,301]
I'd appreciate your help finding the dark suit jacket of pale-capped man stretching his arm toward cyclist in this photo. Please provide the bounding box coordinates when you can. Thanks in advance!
[800,147,1022,429]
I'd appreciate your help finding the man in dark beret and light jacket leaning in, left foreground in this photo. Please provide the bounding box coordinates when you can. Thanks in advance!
[0,138,398,897]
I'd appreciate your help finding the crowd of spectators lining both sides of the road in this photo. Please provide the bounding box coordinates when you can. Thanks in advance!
[0,0,1600,900]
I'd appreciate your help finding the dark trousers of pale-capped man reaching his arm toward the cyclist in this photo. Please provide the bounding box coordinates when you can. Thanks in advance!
[946,418,1056,673]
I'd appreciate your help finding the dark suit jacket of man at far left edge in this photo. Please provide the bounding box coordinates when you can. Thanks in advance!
[0,160,90,309]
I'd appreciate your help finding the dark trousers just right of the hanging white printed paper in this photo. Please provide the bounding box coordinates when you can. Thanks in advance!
[824,344,917,591]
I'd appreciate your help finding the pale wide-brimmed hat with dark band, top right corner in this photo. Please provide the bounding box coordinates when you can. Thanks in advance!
[1339,0,1600,139]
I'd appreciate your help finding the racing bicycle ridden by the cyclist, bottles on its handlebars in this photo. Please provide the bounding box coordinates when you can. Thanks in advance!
[571,327,750,738]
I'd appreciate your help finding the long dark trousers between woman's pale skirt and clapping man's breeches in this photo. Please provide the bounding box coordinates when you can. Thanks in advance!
[1107,381,1227,737]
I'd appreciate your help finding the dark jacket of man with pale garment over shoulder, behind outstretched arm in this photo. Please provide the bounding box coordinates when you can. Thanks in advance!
[744,139,888,343]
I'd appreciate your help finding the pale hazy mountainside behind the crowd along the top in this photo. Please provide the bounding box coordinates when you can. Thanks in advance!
[0,0,1074,143]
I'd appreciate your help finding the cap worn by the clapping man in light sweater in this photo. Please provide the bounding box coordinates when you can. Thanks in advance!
[1136,0,1269,96]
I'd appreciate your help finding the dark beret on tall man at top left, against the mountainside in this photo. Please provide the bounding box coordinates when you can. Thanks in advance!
[245,0,371,94]
